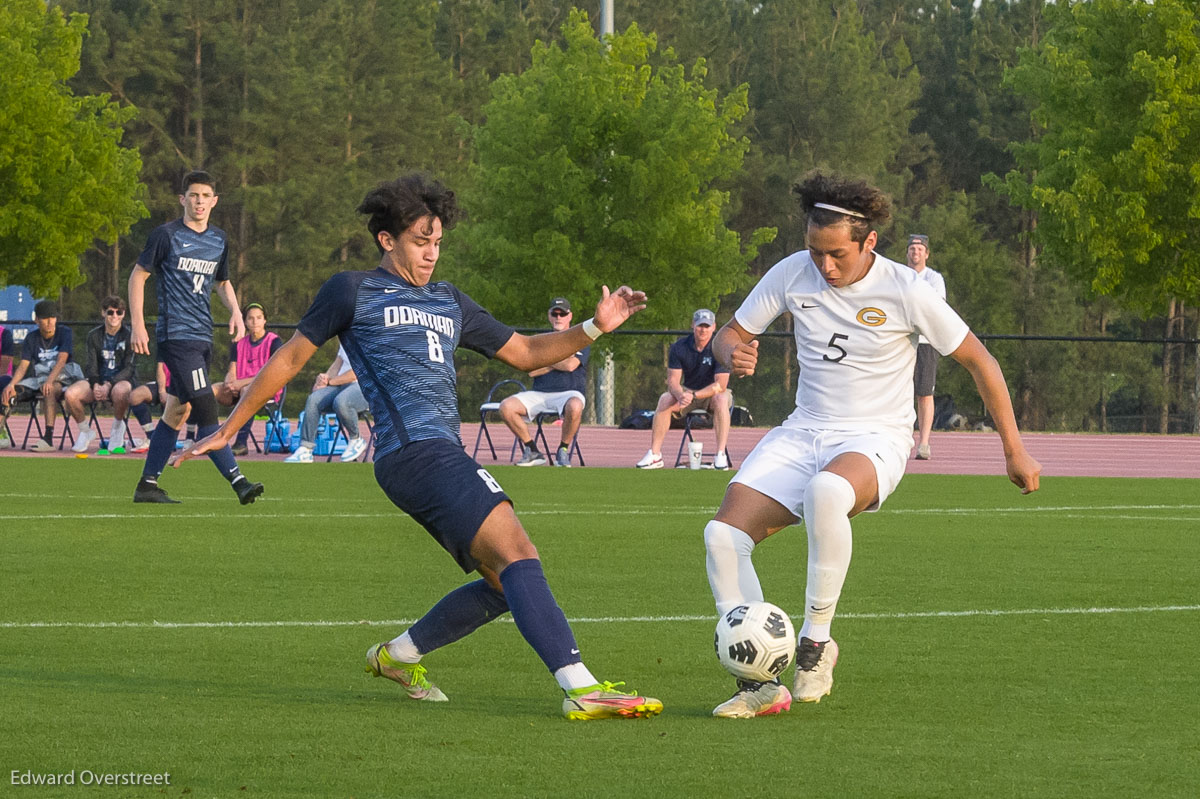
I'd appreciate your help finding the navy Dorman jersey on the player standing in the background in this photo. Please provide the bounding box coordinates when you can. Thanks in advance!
[138,220,229,343]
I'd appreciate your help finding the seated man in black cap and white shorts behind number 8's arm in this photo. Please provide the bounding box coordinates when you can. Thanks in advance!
[500,296,592,467]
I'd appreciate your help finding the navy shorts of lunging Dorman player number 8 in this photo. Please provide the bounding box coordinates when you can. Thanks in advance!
[376,438,512,573]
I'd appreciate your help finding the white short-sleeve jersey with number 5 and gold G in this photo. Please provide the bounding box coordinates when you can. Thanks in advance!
[734,250,970,435]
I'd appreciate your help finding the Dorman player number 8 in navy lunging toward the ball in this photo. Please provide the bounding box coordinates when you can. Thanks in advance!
[180,175,662,719]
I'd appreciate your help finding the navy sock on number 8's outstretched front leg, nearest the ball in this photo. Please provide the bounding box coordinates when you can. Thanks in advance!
[500,558,582,674]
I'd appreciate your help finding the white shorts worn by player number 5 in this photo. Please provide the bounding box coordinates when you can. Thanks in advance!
[733,427,912,518]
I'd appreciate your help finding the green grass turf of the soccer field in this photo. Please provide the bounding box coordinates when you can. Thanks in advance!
[0,458,1200,799]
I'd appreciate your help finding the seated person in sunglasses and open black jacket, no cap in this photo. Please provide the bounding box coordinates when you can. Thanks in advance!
[62,296,136,453]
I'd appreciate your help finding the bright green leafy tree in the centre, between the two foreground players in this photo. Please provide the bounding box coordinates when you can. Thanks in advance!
[448,12,773,328]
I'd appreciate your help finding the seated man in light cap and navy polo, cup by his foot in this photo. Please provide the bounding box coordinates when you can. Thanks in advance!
[637,308,733,469]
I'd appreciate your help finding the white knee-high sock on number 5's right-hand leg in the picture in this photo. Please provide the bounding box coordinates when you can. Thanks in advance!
[800,471,854,642]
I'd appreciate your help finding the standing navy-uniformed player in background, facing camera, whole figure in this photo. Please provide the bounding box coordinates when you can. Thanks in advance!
[130,172,263,505]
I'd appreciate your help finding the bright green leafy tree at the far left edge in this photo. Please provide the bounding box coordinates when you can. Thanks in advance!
[0,0,146,295]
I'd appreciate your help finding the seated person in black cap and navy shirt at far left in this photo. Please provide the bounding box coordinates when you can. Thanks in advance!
[0,300,84,452]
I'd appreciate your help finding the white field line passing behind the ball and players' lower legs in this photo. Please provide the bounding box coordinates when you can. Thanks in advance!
[0,605,1200,630]
